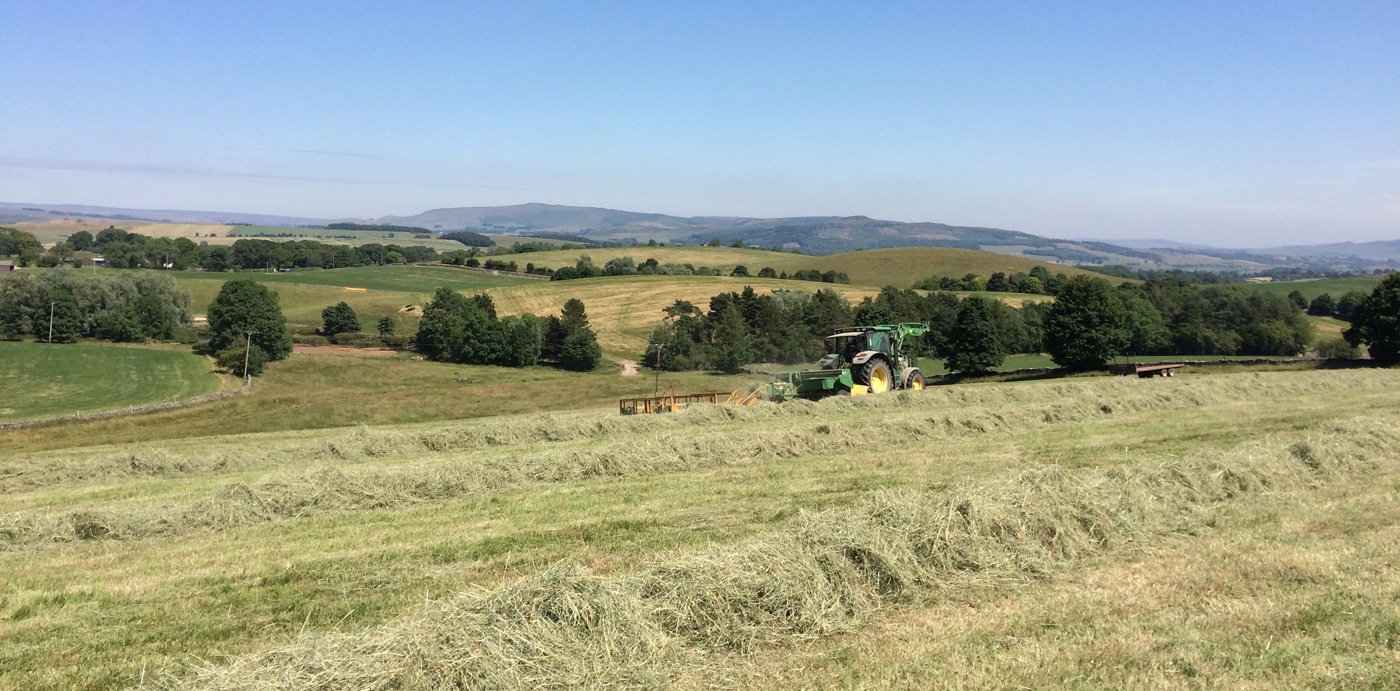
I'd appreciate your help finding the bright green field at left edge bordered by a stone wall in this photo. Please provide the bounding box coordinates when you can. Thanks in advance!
[0,341,220,422]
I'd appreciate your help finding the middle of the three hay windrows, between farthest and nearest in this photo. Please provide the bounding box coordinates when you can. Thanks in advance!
[0,366,1394,550]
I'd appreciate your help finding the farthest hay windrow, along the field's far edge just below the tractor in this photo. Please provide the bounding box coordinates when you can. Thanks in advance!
[0,371,1400,492]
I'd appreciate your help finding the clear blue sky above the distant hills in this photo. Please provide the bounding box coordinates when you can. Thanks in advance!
[0,0,1400,246]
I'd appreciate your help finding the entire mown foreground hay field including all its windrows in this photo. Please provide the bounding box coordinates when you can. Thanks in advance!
[0,371,1400,688]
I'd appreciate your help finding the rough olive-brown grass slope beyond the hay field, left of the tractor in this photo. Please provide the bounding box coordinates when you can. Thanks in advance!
[0,351,766,453]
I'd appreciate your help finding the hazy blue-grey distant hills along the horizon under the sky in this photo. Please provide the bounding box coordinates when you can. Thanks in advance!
[0,203,1400,273]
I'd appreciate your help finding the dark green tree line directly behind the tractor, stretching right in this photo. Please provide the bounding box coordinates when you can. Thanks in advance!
[643,274,1400,373]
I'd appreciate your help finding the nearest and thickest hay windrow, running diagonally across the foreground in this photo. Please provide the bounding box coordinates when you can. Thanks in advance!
[165,417,1400,690]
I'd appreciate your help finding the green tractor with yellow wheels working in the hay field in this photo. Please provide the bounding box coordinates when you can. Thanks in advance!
[766,322,928,401]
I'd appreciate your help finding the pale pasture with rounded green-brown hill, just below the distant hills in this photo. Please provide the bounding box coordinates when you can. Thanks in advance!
[481,245,1098,288]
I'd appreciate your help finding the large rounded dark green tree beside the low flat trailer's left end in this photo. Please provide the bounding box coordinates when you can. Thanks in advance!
[1044,274,1130,369]
